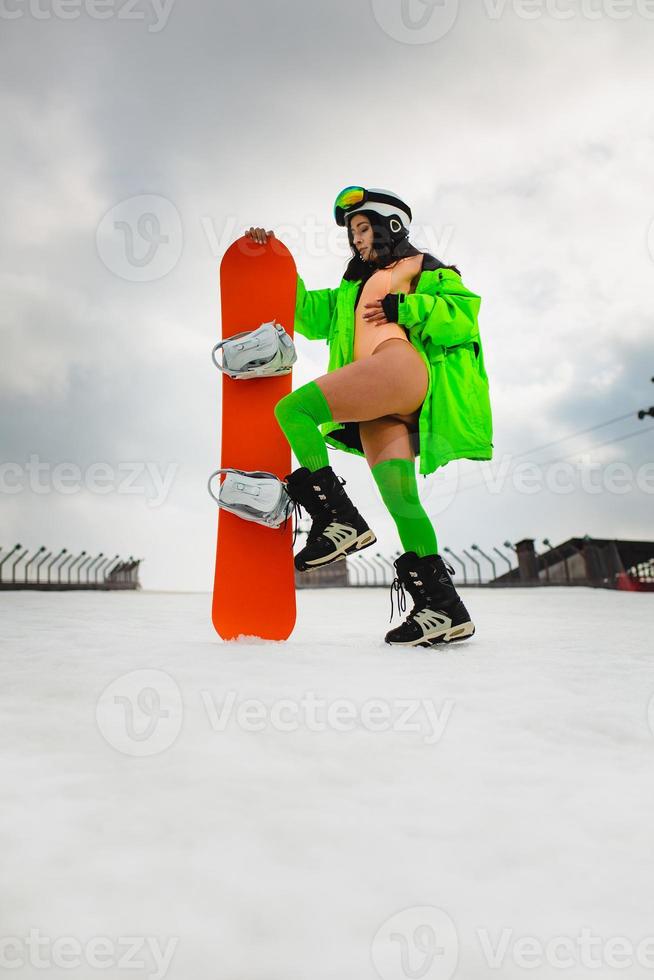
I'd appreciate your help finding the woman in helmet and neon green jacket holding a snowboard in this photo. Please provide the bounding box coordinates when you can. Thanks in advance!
[245,187,492,646]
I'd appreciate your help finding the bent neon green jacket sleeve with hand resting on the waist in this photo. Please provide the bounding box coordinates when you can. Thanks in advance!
[397,269,481,347]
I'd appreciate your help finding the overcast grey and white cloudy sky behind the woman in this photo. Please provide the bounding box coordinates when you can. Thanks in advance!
[0,0,654,589]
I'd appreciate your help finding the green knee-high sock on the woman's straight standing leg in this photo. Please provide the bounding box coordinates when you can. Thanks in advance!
[371,459,438,558]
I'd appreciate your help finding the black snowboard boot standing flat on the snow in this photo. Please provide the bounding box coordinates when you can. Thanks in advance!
[385,551,475,647]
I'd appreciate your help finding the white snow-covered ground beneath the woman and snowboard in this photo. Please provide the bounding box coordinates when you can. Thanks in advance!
[0,588,654,980]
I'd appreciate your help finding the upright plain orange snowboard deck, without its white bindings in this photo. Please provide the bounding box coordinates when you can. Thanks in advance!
[212,236,297,640]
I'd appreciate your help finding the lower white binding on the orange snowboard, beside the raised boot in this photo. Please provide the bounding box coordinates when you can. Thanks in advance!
[208,468,295,528]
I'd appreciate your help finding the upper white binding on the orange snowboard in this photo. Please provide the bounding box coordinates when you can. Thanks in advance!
[211,320,297,380]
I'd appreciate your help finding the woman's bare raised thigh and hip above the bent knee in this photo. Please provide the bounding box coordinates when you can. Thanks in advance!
[315,338,429,422]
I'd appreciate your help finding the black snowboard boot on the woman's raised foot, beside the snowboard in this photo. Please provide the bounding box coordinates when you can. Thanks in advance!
[284,466,377,572]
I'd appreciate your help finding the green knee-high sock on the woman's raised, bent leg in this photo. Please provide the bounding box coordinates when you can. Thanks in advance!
[275,381,333,473]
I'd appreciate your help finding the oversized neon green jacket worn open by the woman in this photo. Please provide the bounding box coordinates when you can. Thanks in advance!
[295,254,493,476]
